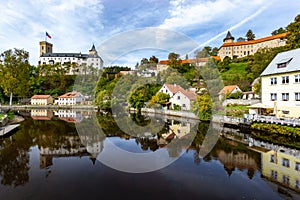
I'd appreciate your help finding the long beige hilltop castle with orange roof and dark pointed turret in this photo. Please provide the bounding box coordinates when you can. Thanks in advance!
[218,31,287,60]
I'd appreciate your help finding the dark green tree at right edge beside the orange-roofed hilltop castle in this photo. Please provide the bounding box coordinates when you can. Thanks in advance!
[286,14,300,49]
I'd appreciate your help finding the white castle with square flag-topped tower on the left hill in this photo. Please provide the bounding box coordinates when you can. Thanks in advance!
[39,41,103,74]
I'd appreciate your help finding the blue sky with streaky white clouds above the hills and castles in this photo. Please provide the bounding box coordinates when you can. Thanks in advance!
[0,0,300,67]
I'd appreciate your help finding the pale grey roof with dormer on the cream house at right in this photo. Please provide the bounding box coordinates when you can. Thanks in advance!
[260,48,300,76]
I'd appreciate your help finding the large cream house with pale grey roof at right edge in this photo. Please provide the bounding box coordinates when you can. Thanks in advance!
[261,48,300,118]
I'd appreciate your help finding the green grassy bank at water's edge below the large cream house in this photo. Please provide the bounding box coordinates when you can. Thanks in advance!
[251,123,300,149]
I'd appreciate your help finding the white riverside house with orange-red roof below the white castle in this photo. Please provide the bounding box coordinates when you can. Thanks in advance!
[55,92,85,105]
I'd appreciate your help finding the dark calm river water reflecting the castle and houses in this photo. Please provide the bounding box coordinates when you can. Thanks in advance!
[0,110,300,200]
